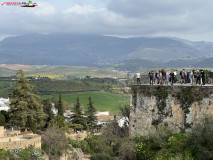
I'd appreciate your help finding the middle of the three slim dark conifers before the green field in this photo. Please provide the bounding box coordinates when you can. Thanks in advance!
[71,97,86,130]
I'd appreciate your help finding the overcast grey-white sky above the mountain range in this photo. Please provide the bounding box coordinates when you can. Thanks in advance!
[0,0,213,42]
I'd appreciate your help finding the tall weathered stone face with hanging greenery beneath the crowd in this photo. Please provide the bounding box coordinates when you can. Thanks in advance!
[130,85,213,136]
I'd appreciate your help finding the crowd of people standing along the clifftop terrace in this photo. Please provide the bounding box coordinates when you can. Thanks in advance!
[136,69,213,85]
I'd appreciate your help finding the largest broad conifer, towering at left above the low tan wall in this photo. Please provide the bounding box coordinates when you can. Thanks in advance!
[9,70,46,132]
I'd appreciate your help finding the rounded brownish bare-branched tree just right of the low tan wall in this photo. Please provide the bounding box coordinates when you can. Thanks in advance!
[41,127,68,160]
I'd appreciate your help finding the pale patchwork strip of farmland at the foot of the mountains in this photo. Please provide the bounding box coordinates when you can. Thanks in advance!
[0,64,126,79]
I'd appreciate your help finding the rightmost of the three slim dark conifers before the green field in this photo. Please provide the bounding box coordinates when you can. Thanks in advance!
[86,97,97,131]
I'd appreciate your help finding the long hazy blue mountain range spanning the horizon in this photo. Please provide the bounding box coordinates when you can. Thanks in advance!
[0,34,213,66]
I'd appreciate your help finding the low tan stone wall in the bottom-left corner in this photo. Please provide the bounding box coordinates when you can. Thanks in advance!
[0,135,41,150]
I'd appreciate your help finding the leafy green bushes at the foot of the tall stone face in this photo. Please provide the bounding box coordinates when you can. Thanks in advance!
[133,126,194,160]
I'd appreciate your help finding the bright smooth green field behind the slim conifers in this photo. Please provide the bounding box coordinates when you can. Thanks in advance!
[41,91,130,113]
